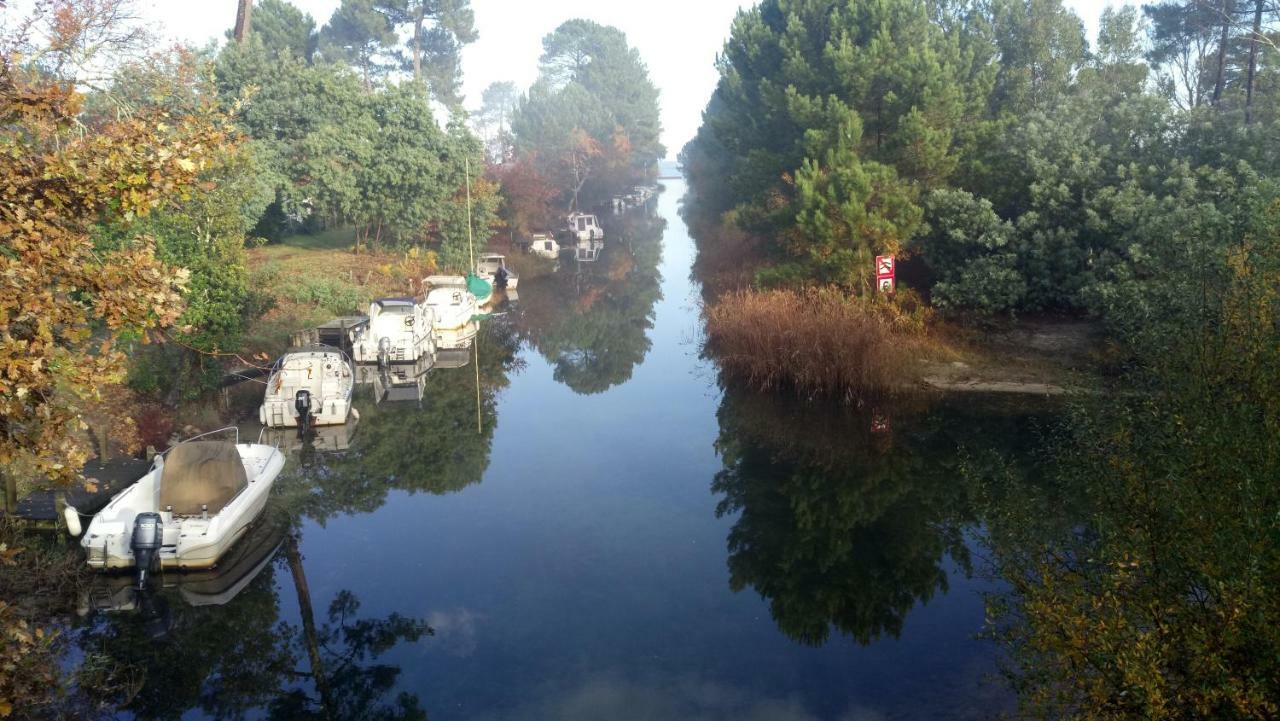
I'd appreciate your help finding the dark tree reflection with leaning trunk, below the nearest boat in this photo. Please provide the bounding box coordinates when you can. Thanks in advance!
[68,519,431,720]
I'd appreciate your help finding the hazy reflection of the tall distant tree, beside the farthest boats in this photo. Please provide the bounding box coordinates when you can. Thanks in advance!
[520,213,667,394]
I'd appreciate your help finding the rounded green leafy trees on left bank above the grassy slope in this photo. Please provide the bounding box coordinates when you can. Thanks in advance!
[218,38,497,269]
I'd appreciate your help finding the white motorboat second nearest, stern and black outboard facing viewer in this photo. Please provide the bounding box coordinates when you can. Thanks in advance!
[257,346,356,430]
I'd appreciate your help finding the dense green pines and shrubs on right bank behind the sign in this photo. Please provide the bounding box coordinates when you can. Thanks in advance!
[681,0,1280,314]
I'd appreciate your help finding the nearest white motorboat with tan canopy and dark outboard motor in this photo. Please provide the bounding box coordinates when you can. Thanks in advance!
[76,428,284,587]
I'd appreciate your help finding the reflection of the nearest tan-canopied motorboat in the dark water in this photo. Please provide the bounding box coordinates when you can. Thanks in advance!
[79,523,287,615]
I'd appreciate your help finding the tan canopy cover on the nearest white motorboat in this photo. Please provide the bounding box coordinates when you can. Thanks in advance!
[160,441,248,516]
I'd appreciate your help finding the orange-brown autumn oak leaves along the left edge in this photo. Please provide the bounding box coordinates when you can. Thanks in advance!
[0,56,230,480]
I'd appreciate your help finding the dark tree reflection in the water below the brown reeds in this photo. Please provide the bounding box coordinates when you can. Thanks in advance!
[712,388,1032,645]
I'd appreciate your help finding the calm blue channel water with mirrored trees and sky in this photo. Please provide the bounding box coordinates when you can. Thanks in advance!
[64,182,1054,721]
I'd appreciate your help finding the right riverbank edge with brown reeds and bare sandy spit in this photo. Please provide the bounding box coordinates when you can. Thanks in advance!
[704,288,1103,400]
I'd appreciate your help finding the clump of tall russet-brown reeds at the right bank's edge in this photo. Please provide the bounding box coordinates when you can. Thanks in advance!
[707,288,928,400]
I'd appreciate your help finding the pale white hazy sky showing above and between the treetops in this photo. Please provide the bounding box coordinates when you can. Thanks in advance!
[141,0,1136,156]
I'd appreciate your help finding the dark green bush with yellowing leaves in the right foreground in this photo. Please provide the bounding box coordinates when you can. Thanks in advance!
[989,218,1280,720]
